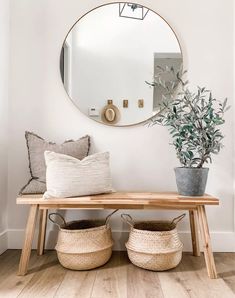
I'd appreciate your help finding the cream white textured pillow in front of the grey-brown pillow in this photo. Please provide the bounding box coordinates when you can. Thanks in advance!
[43,151,112,198]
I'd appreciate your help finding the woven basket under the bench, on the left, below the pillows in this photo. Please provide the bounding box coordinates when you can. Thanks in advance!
[49,210,117,270]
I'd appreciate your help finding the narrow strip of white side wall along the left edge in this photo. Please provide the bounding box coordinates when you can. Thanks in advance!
[0,0,9,254]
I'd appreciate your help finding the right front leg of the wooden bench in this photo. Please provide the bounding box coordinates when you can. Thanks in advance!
[198,205,217,278]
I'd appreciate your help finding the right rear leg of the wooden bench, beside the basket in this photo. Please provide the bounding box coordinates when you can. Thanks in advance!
[189,210,200,257]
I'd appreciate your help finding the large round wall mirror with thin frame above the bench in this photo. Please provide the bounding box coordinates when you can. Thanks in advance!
[60,2,182,126]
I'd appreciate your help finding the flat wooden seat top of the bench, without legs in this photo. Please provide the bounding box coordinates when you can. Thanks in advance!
[17,192,219,209]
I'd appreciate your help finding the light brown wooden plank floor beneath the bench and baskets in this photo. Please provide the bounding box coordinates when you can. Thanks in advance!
[0,250,235,298]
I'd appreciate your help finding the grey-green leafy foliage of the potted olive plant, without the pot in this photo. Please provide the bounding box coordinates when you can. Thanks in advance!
[144,66,230,167]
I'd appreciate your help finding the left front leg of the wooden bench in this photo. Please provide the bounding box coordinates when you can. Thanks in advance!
[18,205,38,275]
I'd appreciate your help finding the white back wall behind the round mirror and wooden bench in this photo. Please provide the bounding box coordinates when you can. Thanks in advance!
[8,0,235,251]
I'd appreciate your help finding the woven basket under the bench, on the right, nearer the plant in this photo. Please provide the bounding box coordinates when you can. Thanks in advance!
[121,214,185,271]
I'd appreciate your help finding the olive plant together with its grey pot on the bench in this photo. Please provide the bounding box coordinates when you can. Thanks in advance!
[148,68,229,196]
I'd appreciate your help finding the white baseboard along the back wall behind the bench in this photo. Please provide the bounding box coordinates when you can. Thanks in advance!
[6,229,235,252]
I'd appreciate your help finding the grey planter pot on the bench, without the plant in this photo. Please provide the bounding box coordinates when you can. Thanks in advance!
[175,167,209,196]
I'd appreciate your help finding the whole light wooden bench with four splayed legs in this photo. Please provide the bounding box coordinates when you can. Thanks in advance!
[17,192,219,278]
